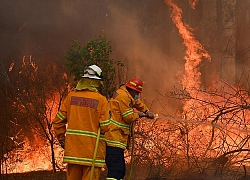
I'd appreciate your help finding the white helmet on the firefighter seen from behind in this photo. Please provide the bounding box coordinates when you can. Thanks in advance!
[82,65,103,80]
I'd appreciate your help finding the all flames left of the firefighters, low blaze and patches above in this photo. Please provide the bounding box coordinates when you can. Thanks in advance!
[1,59,66,174]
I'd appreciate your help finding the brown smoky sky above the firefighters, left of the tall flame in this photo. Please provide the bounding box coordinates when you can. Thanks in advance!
[0,0,190,113]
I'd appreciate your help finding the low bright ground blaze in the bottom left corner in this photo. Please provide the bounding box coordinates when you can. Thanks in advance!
[2,136,64,173]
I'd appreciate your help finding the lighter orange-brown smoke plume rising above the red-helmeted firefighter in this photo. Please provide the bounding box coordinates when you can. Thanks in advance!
[104,1,184,111]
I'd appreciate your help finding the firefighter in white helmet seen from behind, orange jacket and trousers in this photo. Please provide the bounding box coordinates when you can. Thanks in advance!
[53,65,110,180]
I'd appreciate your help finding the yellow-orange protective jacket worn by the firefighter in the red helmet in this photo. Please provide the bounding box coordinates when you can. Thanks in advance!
[105,86,149,149]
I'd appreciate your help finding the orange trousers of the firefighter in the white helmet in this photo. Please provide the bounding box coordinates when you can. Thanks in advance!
[67,164,101,180]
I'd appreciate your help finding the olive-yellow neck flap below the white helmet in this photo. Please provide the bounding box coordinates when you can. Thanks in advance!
[75,78,102,91]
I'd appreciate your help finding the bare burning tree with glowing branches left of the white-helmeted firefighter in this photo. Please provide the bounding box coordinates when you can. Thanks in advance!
[2,56,69,174]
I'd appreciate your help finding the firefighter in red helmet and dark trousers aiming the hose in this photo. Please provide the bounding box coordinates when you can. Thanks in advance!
[105,78,154,180]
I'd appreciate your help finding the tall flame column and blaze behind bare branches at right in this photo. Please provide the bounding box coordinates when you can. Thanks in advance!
[165,0,249,170]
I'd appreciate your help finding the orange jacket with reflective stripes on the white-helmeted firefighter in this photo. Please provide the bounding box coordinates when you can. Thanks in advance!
[53,89,109,167]
